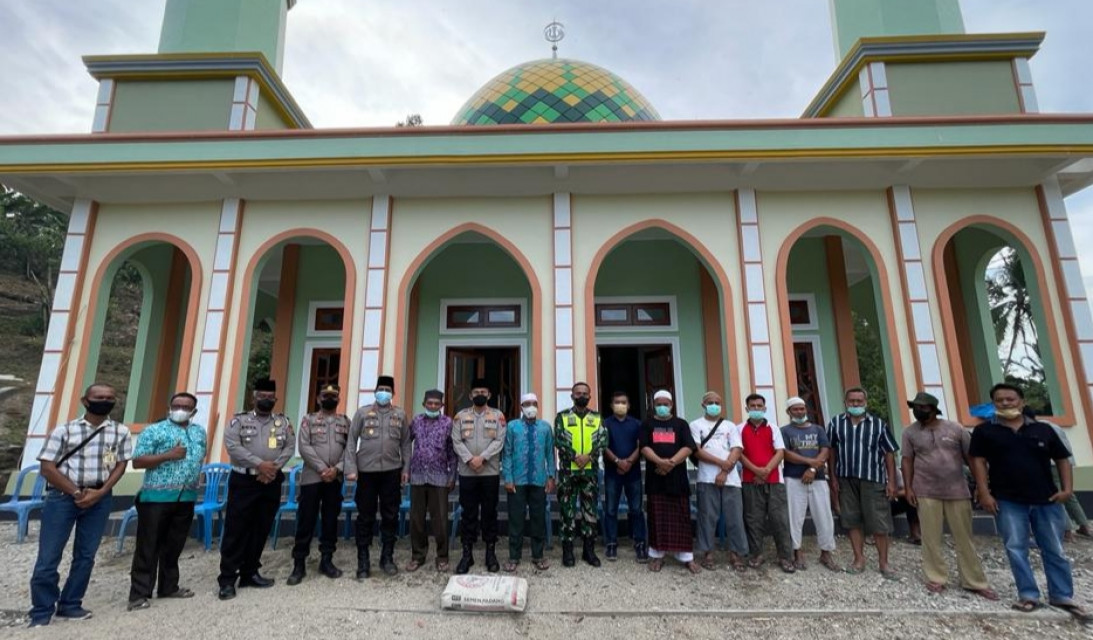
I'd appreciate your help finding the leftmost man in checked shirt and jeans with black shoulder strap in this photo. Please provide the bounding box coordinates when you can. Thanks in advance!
[30,383,132,627]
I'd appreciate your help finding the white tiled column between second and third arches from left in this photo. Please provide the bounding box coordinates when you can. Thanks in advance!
[356,193,391,410]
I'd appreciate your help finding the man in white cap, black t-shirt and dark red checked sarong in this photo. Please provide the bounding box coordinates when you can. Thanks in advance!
[642,389,702,574]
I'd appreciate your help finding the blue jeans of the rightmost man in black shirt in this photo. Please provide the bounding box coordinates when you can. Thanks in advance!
[995,500,1074,604]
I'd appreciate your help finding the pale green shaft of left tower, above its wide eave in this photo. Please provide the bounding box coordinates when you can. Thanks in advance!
[160,0,289,72]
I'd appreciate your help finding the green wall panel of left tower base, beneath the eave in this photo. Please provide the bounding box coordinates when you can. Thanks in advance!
[110,80,234,133]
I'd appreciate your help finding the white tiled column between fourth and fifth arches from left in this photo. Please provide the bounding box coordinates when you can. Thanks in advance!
[727,189,788,424]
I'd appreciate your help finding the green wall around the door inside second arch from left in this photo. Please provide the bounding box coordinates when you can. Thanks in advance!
[281,245,343,424]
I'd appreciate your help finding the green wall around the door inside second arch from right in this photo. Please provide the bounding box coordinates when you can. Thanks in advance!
[786,238,843,410]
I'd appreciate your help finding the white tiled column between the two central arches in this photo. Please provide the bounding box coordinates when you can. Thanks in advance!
[553,192,577,411]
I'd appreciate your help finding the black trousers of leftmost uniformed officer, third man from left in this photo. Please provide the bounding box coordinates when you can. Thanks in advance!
[216,471,284,586]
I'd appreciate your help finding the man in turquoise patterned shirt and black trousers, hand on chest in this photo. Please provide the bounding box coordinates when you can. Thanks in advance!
[127,392,205,611]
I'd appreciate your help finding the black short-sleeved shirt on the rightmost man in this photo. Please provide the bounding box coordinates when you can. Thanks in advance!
[968,418,1070,505]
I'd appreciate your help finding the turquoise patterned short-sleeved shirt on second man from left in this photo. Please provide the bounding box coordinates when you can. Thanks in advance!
[133,420,205,502]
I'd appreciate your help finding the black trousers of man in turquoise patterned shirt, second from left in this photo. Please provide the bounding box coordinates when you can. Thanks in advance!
[129,495,193,602]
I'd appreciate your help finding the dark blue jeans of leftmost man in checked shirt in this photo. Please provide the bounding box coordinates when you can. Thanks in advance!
[30,489,110,620]
